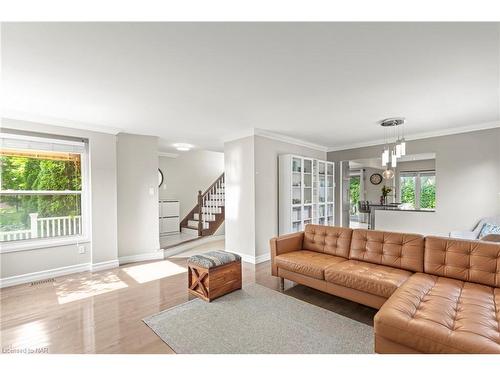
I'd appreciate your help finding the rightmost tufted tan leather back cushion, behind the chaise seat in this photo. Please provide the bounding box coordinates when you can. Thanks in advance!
[424,236,500,288]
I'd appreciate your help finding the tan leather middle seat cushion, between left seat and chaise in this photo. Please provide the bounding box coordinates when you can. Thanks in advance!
[325,260,411,298]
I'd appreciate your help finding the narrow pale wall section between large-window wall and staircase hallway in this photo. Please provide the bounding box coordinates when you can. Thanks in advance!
[116,133,160,259]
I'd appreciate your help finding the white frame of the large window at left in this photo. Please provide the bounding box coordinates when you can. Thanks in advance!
[0,133,91,254]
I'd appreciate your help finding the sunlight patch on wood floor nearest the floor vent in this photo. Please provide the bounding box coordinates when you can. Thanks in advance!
[56,272,128,304]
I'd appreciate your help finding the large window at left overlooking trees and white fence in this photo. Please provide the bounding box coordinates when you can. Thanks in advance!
[0,134,87,246]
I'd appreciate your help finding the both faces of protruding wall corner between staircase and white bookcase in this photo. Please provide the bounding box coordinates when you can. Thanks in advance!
[224,136,326,263]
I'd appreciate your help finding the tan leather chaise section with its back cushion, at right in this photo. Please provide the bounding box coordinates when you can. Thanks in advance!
[374,237,500,353]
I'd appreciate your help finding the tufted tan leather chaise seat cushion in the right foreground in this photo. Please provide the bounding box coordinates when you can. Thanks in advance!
[375,273,500,353]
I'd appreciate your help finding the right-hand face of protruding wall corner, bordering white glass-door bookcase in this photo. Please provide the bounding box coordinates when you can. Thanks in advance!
[254,136,326,259]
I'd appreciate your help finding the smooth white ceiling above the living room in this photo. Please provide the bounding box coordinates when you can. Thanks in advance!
[1,23,500,152]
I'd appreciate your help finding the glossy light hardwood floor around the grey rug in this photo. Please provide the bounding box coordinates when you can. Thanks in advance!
[0,248,376,353]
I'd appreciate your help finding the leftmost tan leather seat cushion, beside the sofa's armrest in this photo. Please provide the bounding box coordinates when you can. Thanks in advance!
[276,250,347,280]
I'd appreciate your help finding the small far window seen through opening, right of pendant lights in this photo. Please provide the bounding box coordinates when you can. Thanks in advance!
[399,171,436,210]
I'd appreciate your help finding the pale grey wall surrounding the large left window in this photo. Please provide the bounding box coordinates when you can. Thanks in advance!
[0,118,118,279]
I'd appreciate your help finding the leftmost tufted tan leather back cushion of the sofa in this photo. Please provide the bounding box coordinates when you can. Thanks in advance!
[303,224,352,259]
